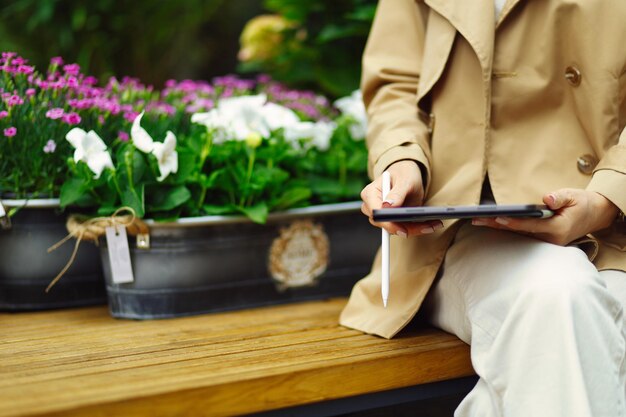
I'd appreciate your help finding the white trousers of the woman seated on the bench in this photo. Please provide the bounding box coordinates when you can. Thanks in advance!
[423,225,626,417]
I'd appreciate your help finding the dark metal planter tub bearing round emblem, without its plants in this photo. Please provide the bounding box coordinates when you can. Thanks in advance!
[100,202,380,319]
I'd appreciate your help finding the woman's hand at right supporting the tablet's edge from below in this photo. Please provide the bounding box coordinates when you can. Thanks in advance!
[472,188,619,246]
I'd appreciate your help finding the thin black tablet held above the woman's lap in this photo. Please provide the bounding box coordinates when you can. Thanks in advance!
[374,204,554,222]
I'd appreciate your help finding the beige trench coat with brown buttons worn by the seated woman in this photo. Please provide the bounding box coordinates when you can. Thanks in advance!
[340,0,626,338]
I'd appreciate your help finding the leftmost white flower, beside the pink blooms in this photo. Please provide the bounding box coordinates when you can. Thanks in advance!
[65,127,113,179]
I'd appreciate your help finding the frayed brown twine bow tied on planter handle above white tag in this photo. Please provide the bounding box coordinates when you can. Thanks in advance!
[46,207,149,292]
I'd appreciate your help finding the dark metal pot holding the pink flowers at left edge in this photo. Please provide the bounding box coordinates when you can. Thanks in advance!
[0,199,106,311]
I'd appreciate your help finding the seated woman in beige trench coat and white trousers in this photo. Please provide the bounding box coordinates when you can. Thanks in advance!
[340,0,626,417]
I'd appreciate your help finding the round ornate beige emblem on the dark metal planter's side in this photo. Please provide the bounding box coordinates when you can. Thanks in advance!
[268,220,329,291]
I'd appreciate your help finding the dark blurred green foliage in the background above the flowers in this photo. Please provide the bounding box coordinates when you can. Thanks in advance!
[0,0,376,97]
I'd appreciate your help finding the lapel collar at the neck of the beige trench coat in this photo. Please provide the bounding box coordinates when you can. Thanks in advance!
[424,0,524,74]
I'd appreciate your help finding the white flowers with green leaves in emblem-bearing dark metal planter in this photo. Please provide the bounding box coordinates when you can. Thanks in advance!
[50,69,377,318]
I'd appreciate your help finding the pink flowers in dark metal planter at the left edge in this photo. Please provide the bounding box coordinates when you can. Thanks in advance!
[0,52,111,310]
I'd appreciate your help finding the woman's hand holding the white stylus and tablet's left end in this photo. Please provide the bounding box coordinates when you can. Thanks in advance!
[361,160,443,237]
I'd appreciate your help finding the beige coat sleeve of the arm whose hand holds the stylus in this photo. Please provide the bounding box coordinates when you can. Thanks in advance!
[361,0,430,181]
